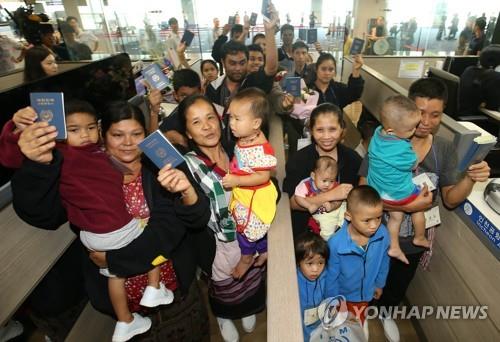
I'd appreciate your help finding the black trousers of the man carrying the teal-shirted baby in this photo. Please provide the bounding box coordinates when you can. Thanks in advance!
[370,252,424,312]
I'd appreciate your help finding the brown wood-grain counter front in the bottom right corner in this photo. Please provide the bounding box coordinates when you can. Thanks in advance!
[407,183,500,341]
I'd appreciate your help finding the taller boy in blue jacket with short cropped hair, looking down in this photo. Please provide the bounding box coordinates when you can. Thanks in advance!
[327,185,390,324]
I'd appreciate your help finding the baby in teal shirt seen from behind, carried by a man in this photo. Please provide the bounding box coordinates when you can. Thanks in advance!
[367,95,429,264]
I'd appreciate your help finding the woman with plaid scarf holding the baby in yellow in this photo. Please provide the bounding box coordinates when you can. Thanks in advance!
[179,95,266,342]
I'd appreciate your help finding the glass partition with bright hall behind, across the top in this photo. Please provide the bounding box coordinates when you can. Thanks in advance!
[0,0,500,75]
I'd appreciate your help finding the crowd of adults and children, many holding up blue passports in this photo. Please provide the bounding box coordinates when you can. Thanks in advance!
[0,5,489,342]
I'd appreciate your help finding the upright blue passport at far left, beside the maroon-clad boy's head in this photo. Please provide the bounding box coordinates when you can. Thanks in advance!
[30,93,67,140]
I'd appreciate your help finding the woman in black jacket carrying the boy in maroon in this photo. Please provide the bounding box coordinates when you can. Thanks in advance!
[12,102,210,341]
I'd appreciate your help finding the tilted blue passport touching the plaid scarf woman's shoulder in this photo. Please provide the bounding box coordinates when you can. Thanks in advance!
[139,130,184,169]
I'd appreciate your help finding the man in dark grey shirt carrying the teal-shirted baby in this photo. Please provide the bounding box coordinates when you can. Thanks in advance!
[359,78,490,341]
